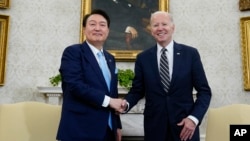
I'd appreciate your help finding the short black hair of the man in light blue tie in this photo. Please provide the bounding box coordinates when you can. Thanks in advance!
[82,9,110,27]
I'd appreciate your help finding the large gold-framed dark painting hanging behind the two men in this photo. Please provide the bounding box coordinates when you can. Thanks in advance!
[80,0,169,62]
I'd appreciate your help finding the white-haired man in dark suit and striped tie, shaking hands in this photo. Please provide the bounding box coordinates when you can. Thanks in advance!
[123,11,212,141]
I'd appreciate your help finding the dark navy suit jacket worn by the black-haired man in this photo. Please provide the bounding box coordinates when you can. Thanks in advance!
[57,42,121,141]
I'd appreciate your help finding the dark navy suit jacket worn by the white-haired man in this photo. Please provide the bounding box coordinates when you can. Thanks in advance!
[125,42,211,141]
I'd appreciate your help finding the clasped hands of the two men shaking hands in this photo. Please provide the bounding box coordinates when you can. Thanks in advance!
[109,98,128,114]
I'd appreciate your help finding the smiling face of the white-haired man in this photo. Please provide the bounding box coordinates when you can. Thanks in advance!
[150,11,174,47]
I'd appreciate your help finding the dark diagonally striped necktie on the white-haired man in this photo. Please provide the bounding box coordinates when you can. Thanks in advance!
[160,48,170,92]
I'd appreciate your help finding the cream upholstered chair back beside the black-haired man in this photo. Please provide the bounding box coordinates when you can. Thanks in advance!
[0,102,61,141]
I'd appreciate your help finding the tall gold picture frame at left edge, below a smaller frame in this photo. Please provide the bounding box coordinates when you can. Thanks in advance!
[0,15,9,85]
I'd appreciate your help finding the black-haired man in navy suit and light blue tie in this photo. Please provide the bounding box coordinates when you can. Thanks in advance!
[57,10,122,141]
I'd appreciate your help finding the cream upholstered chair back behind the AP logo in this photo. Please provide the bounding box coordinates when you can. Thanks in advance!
[206,104,250,141]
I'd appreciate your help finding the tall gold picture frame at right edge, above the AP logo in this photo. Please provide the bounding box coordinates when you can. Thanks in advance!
[240,17,250,91]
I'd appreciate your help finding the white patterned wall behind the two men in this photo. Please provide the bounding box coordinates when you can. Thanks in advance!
[0,0,250,137]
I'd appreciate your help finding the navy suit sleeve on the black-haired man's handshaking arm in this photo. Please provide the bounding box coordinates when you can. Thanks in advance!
[60,46,105,107]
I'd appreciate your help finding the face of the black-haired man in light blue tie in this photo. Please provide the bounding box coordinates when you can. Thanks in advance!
[84,14,109,47]
